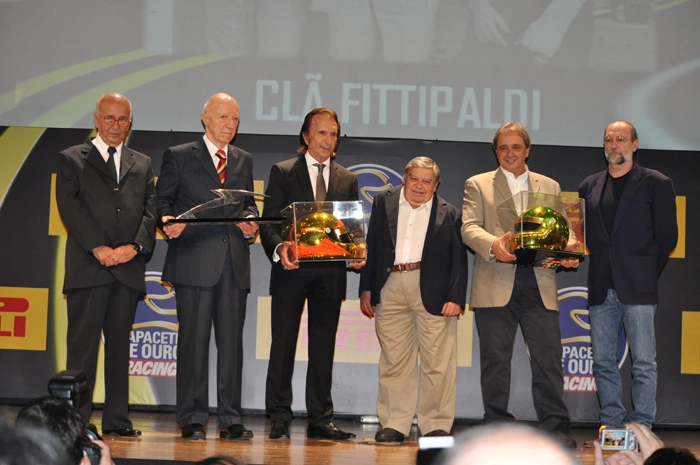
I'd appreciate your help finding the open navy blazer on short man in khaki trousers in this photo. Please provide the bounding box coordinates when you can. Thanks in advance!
[360,186,468,315]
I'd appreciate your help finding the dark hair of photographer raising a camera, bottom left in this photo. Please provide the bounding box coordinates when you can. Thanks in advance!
[15,396,85,463]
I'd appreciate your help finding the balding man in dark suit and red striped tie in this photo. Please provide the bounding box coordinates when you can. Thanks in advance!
[156,93,258,439]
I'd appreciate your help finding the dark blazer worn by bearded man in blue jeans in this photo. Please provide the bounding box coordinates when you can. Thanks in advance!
[579,162,678,305]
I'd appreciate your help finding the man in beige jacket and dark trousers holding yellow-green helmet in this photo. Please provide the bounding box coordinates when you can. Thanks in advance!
[462,123,577,448]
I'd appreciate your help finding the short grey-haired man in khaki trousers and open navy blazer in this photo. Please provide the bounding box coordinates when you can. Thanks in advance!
[360,157,467,442]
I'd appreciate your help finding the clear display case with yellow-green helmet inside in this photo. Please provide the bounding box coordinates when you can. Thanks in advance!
[496,191,587,268]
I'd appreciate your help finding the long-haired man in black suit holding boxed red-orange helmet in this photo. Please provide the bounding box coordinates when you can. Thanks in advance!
[260,108,365,439]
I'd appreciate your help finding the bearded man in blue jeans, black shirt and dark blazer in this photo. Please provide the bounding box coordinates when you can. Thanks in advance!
[579,121,678,428]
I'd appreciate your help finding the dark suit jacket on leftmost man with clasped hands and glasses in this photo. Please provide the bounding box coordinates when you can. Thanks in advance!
[56,142,156,294]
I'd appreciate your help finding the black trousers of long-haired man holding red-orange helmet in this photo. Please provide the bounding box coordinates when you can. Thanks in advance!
[265,273,343,426]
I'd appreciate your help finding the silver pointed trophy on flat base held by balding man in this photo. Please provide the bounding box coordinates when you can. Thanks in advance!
[169,189,285,224]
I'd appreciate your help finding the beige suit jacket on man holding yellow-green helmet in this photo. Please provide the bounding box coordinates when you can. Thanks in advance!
[462,169,561,310]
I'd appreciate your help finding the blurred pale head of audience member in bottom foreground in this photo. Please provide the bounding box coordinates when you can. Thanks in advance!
[442,423,578,465]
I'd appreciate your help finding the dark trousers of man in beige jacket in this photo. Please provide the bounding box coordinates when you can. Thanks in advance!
[475,268,570,430]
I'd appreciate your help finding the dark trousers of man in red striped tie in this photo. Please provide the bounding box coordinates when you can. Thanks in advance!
[175,254,248,428]
